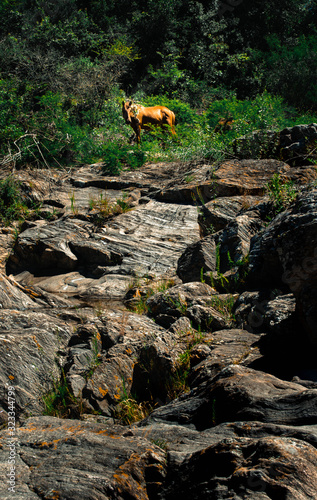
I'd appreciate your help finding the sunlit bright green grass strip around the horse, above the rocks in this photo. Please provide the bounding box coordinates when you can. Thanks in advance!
[0,81,317,174]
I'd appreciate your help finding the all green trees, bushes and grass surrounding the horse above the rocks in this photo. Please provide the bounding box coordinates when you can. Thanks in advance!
[0,0,317,180]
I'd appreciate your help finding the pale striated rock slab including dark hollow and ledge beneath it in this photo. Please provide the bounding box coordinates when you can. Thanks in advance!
[8,200,199,299]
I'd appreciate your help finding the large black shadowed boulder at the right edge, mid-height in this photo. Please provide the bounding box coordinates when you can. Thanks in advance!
[248,189,317,345]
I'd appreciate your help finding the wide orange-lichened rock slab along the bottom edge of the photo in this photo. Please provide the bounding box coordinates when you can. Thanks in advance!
[0,417,317,500]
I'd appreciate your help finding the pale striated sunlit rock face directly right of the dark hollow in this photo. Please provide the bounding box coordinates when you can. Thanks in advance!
[101,200,199,275]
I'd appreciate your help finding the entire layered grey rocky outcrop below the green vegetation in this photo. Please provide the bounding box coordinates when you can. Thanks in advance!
[0,155,317,500]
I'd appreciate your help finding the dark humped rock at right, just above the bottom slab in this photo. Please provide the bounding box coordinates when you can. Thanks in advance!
[146,365,317,430]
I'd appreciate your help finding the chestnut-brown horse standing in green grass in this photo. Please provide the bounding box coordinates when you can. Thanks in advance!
[122,101,176,143]
